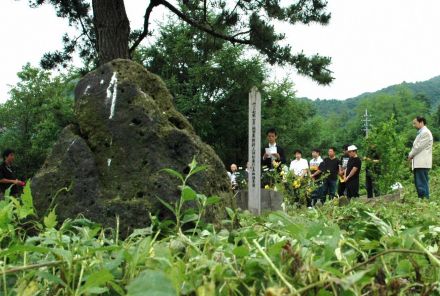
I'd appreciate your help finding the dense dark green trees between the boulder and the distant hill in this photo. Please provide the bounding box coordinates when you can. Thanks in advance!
[135,23,316,164]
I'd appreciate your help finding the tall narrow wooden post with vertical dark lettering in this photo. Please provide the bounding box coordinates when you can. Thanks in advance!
[248,86,261,215]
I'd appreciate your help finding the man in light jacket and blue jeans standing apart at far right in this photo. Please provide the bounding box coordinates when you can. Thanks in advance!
[408,116,433,198]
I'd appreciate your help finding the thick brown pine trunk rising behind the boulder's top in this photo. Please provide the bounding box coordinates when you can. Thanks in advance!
[92,0,130,65]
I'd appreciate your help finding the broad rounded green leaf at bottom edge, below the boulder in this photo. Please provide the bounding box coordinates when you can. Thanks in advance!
[127,270,177,296]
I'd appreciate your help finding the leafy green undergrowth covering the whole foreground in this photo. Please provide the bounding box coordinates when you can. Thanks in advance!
[0,168,440,296]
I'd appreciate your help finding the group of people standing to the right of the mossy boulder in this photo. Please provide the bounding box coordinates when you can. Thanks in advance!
[229,116,433,203]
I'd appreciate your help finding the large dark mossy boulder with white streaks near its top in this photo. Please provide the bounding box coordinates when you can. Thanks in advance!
[32,60,231,233]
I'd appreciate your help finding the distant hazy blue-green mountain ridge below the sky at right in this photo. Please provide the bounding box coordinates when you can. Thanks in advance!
[306,76,440,116]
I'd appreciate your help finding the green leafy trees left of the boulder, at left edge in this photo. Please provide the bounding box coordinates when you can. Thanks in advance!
[0,64,74,178]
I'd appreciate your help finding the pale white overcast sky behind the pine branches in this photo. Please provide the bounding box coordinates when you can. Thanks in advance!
[0,0,440,102]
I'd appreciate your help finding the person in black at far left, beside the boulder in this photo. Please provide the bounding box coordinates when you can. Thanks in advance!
[0,149,24,197]
